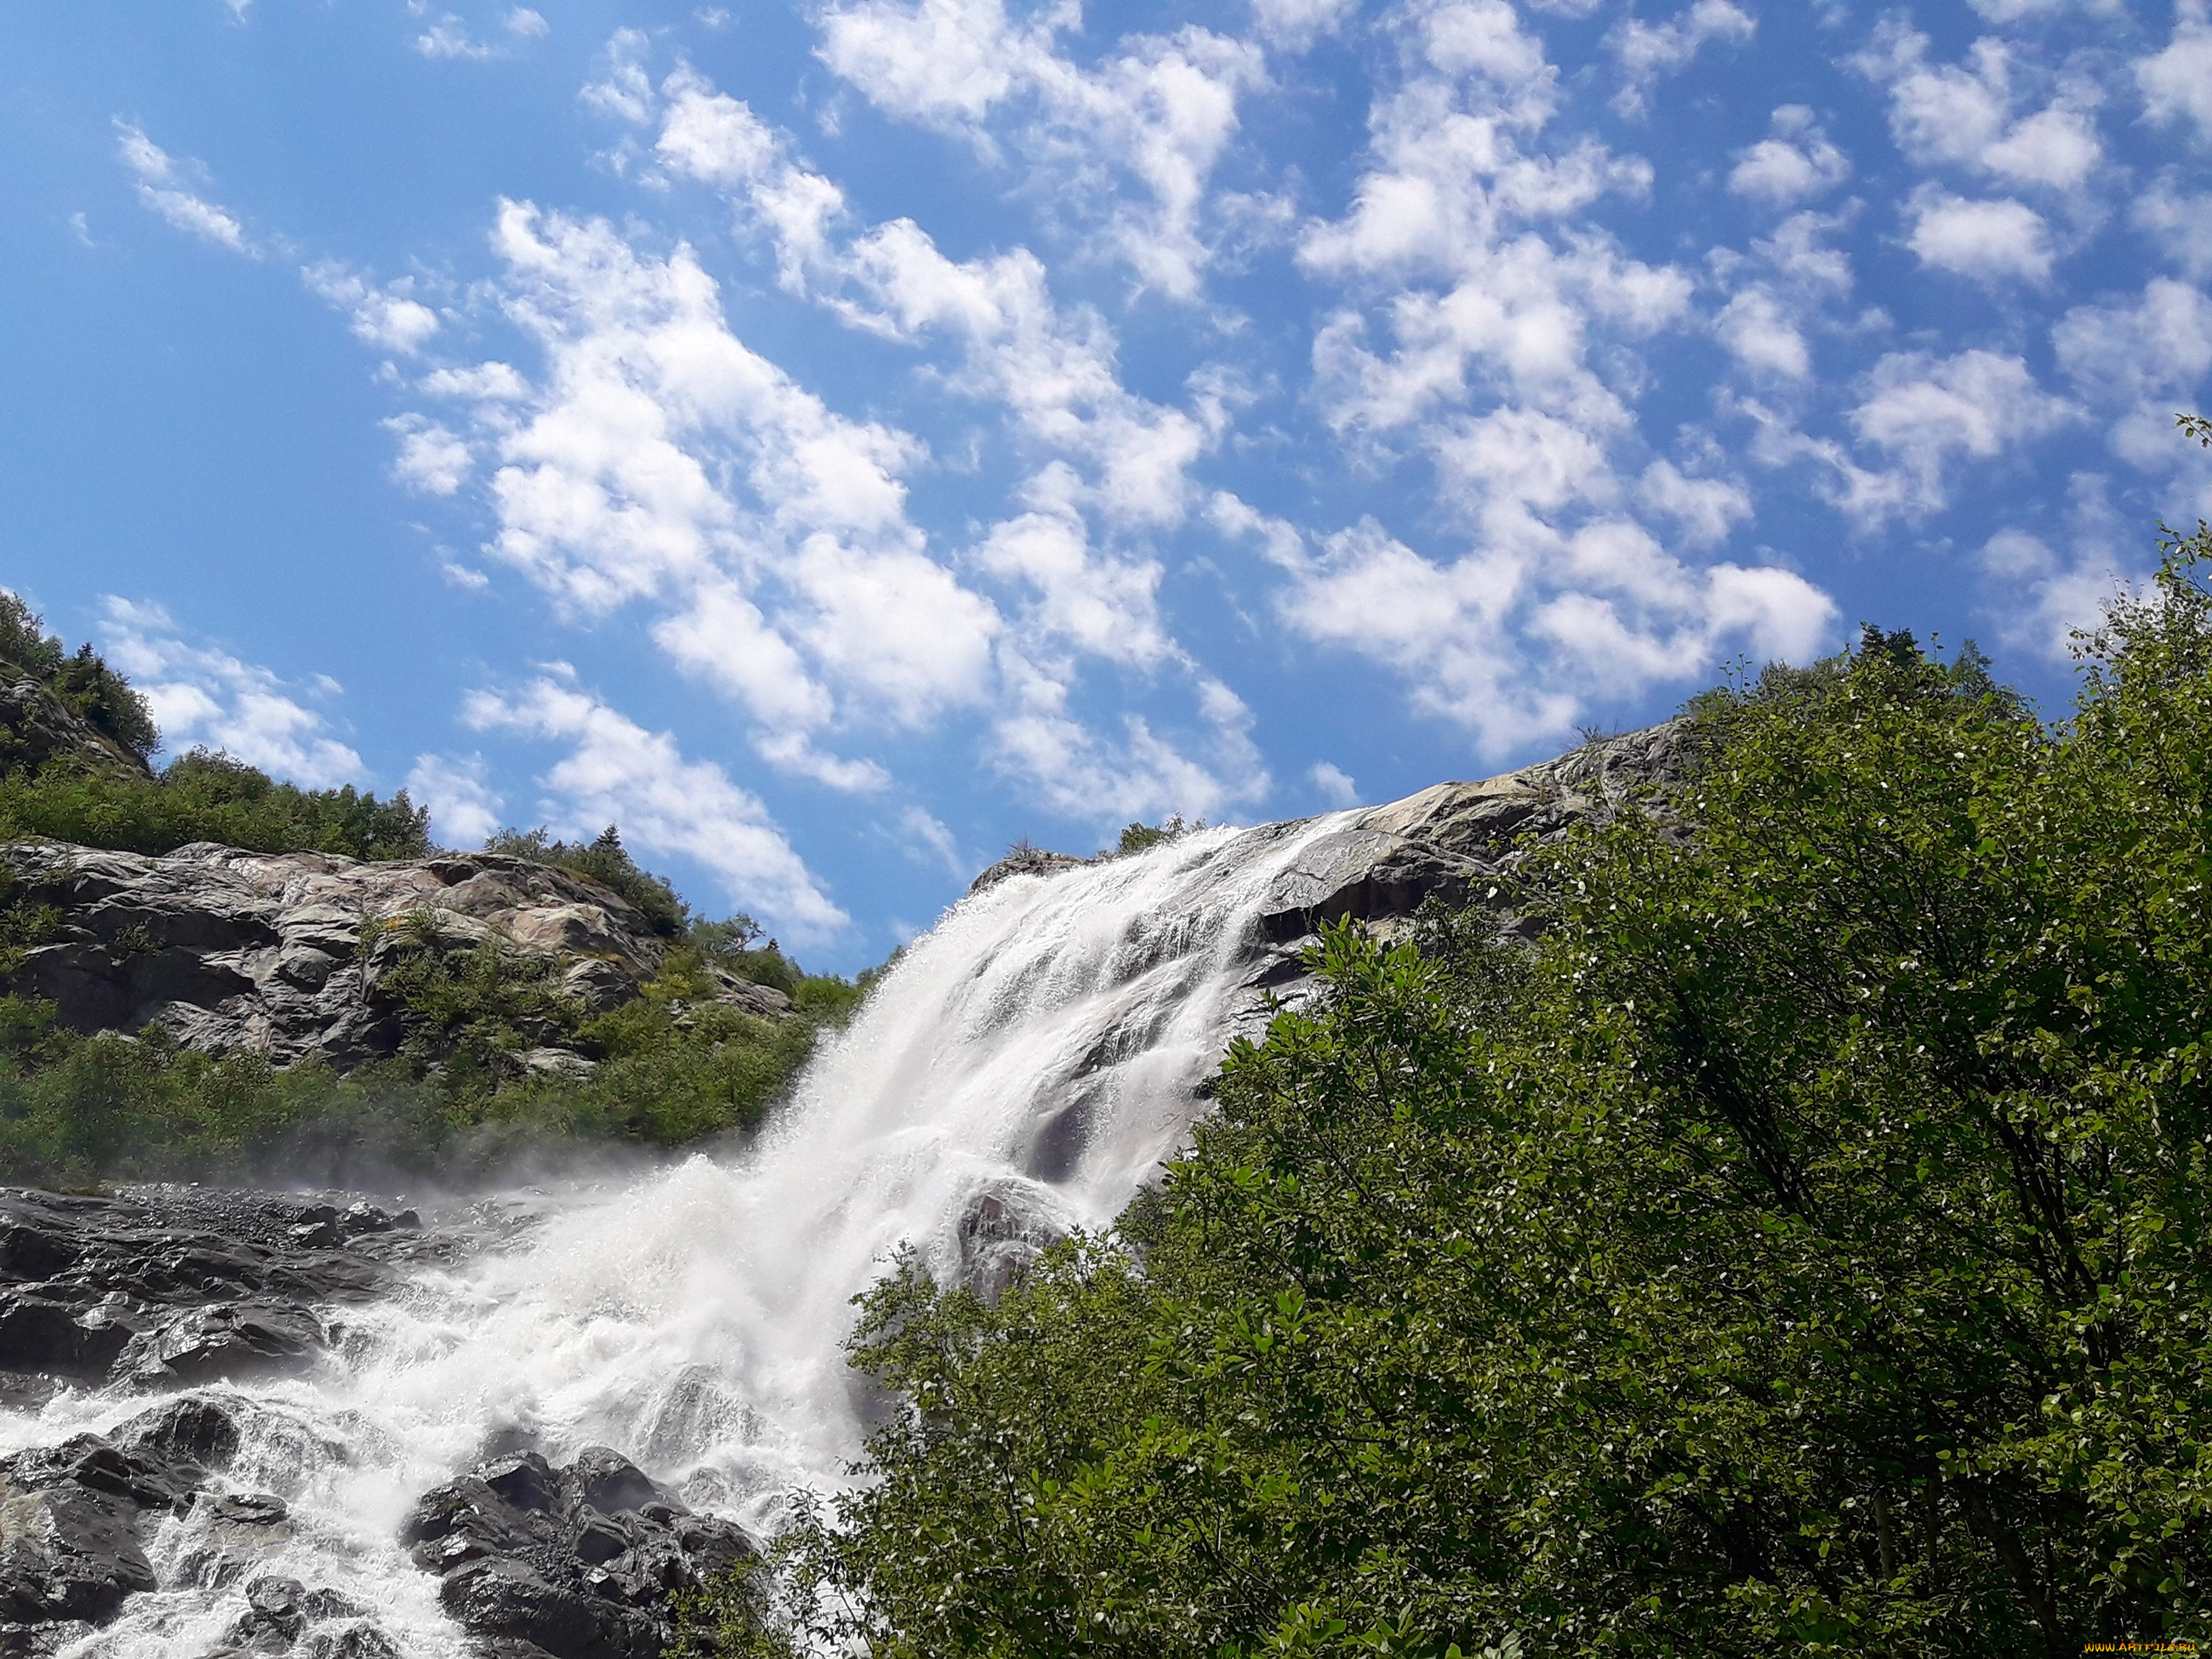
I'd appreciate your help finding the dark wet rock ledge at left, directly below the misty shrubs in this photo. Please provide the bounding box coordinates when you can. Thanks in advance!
[0,1186,469,1405]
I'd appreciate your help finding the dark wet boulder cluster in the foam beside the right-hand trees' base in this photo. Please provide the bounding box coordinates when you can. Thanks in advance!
[401,1446,756,1659]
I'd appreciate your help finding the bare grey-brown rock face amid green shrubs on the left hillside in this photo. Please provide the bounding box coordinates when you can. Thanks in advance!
[0,841,666,1069]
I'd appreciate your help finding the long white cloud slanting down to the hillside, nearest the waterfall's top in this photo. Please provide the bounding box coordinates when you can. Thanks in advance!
[462,668,849,940]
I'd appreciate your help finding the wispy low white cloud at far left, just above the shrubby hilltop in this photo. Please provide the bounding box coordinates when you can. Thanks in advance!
[100,595,362,790]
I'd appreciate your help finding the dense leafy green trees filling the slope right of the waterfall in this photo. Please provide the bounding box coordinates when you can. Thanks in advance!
[686,533,2212,1659]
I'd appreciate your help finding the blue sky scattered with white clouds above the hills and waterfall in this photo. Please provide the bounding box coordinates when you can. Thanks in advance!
[0,0,2212,966]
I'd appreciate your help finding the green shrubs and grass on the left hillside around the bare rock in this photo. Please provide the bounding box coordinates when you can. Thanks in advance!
[0,606,871,1186]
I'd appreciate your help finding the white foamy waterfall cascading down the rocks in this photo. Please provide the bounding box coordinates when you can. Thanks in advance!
[0,816,1343,1659]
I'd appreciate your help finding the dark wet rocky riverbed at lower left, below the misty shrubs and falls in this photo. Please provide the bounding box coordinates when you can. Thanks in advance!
[0,1186,755,1659]
